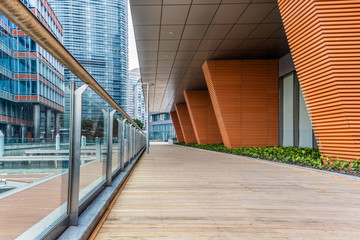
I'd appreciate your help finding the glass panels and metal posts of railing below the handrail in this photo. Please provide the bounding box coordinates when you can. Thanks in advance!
[0,2,146,239]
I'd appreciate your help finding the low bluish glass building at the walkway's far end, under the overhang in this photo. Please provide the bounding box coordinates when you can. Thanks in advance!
[149,113,176,142]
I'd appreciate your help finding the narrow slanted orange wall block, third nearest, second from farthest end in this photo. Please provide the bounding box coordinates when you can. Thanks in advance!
[175,103,196,143]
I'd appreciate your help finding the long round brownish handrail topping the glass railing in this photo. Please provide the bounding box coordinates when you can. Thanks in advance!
[0,0,144,133]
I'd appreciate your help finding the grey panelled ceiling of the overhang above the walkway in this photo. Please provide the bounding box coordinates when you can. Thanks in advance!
[130,0,289,112]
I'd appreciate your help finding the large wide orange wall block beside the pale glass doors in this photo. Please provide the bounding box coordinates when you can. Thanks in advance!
[203,60,278,148]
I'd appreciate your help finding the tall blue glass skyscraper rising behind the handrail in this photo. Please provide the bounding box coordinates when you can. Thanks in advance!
[49,0,128,108]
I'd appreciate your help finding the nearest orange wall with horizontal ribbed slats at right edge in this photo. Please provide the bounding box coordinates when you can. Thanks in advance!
[278,0,360,160]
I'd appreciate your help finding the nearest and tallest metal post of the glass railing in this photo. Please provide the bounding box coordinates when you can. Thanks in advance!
[69,84,88,226]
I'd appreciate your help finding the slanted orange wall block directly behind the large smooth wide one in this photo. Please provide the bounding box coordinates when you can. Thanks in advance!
[184,90,222,144]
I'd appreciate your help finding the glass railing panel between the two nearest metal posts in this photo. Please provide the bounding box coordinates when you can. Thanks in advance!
[79,88,109,203]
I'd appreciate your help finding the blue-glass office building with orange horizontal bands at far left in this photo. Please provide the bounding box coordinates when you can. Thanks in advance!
[0,0,64,142]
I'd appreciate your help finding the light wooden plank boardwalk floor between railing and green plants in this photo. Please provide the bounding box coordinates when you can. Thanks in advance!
[97,145,360,240]
